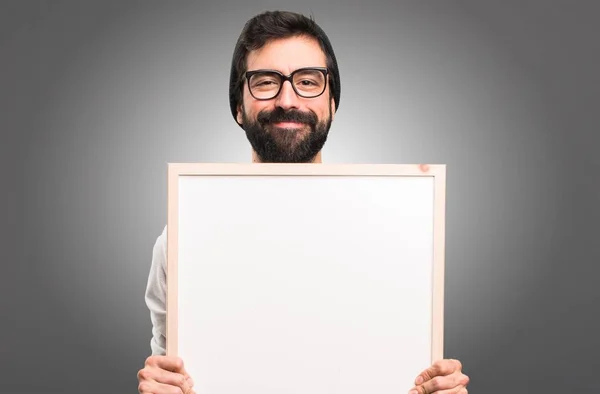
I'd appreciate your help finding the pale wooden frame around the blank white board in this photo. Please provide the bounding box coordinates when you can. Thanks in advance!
[166,163,446,394]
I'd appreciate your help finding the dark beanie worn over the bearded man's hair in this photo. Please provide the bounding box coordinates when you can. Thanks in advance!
[229,11,341,123]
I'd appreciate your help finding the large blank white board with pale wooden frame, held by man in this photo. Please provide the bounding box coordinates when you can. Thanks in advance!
[167,163,445,394]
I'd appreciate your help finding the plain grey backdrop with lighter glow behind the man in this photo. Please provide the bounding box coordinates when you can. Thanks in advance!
[0,0,600,394]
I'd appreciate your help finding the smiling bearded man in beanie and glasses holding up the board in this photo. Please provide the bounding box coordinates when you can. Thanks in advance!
[138,12,469,394]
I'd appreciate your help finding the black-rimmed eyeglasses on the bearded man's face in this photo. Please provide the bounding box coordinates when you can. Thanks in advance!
[246,67,329,100]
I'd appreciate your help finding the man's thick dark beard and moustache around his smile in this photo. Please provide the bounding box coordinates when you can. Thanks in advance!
[242,106,331,163]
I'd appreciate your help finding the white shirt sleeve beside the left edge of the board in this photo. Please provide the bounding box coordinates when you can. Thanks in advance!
[145,226,167,355]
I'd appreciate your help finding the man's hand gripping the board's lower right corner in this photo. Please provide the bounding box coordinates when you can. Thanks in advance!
[409,360,469,394]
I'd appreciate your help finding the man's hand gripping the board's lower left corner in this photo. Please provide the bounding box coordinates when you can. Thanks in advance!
[138,356,195,394]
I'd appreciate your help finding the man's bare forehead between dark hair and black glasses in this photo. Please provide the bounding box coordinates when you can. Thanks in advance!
[247,36,327,74]
